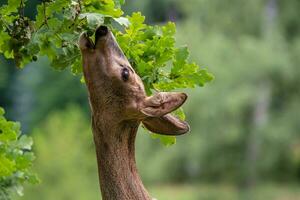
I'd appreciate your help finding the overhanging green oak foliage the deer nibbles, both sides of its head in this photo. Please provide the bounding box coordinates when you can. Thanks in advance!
[0,0,213,144]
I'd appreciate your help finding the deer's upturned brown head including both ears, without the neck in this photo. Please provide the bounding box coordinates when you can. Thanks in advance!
[79,26,189,135]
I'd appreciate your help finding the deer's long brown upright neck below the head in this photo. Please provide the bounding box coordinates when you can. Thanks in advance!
[92,117,151,200]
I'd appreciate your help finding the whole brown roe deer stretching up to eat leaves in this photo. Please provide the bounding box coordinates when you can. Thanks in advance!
[79,26,189,200]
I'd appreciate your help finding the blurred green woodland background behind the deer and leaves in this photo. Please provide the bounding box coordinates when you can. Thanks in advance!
[0,0,300,200]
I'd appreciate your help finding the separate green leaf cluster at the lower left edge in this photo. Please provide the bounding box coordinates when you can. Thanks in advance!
[0,107,39,199]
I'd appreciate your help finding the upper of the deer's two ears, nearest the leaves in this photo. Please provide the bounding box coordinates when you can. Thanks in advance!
[141,92,187,117]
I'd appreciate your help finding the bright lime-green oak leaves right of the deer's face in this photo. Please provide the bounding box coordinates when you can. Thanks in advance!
[116,13,213,94]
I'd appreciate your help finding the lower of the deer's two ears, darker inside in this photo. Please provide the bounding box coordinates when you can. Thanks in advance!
[142,114,190,135]
